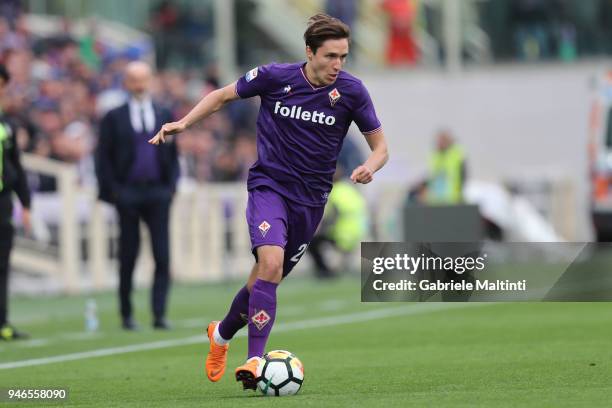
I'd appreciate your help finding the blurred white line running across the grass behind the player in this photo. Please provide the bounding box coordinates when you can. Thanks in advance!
[0,303,478,370]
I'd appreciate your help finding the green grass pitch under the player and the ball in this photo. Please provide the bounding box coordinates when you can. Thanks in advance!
[0,277,612,407]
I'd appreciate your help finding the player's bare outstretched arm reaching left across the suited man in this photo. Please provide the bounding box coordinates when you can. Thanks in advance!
[149,82,239,144]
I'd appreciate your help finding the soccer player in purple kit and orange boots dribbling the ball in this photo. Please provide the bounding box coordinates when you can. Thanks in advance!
[150,14,388,390]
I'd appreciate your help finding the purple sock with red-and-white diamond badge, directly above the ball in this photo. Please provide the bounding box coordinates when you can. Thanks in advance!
[249,279,278,358]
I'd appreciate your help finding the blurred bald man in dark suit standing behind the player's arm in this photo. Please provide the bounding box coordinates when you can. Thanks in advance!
[96,61,179,330]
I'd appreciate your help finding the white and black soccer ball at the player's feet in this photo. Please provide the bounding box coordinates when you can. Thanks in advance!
[257,350,304,397]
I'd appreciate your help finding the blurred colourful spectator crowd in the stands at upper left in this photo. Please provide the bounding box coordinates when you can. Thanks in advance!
[0,2,258,191]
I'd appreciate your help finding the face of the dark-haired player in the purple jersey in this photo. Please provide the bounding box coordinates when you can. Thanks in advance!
[306,38,348,86]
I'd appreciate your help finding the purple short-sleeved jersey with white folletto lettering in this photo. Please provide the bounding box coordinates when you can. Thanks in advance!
[236,62,380,206]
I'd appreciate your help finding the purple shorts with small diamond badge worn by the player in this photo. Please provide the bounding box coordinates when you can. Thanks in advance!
[246,187,325,277]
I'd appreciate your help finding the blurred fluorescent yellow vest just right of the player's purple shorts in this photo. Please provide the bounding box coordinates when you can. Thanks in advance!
[327,181,368,252]
